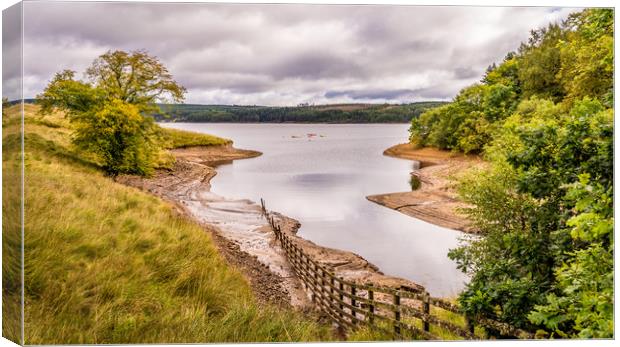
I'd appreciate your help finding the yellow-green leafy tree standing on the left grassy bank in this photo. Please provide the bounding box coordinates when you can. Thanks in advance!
[37,51,185,175]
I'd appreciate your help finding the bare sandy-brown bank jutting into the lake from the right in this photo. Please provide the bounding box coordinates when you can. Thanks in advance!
[366,143,486,233]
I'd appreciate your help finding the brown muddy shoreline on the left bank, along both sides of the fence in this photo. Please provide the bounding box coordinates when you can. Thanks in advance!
[117,146,436,310]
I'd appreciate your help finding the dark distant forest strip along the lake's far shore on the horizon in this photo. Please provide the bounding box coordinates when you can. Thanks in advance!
[154,101,446,123]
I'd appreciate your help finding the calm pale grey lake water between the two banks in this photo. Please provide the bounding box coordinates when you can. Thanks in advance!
[162,123,466,296]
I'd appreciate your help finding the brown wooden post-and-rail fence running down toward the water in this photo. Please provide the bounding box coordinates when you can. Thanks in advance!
[261,199,534,340]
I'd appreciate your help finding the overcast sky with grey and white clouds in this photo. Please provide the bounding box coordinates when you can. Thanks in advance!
[3,2,575,106]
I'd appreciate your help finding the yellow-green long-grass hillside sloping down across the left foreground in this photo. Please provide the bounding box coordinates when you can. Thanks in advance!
[3,105,331,344]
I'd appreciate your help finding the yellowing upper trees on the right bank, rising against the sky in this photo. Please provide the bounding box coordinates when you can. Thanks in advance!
[410,9,614,153]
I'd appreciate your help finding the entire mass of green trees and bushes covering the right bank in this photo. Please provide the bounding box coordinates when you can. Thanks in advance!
[410,8,614,338]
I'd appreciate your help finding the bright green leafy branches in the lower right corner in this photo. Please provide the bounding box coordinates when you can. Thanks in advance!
[529,174,614,338]
